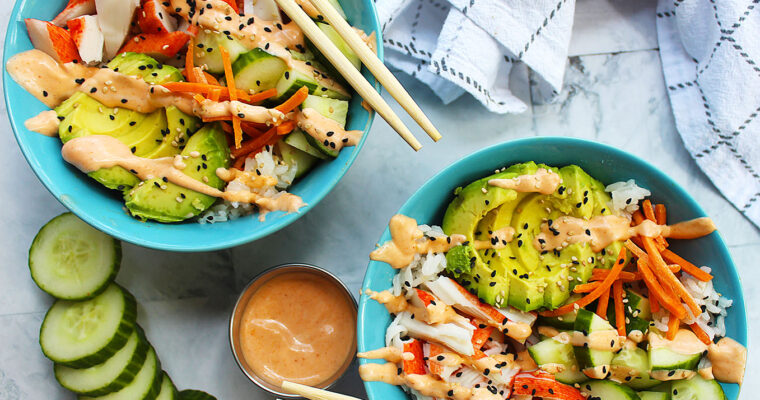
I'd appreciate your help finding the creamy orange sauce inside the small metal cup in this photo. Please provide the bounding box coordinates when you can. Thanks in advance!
[240,272,356,387]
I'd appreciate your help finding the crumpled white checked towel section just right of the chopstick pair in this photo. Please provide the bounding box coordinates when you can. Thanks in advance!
[376,0,575,113]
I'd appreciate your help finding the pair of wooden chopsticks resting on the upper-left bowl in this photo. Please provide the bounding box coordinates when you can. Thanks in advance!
[275,0,441,151]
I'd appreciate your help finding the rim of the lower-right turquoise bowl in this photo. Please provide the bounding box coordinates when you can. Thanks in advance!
[356,136,749,400]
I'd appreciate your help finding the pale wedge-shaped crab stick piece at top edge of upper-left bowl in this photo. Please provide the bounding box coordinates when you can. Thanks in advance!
[95,0,140,60]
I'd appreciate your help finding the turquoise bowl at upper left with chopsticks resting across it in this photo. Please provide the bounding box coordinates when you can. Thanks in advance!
[3,0,383,251]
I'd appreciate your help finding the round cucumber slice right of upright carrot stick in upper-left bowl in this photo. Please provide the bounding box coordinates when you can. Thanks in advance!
[232,48,287,92]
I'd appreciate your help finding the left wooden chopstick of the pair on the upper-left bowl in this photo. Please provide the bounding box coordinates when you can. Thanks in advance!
[275,0,422,151]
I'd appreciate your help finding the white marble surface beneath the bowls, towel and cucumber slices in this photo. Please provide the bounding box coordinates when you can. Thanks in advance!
[0,0,760,400]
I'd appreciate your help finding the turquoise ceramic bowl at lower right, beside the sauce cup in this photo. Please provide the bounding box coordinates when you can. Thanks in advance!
[358,137,747,400]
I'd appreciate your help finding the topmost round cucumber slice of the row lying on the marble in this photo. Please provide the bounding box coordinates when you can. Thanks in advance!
[29,213,121,300]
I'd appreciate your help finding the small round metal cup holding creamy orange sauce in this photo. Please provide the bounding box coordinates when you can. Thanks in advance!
[229,264,357,398]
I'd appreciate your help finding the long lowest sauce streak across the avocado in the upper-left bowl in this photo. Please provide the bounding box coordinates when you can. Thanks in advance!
[61,135,303,212]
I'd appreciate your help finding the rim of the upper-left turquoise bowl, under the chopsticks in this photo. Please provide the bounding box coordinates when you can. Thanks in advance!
[2,0,384,252]
